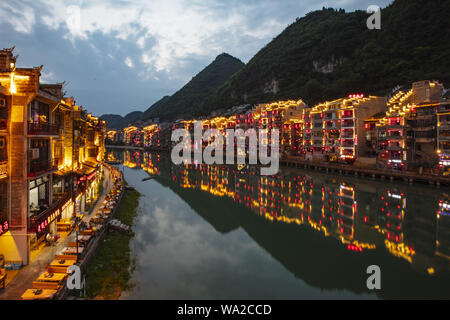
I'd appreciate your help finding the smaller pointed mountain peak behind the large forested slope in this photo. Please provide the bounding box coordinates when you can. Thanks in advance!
[142,53,244,121]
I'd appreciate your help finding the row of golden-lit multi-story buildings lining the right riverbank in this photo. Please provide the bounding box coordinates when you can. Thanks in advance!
[118,81,450,169]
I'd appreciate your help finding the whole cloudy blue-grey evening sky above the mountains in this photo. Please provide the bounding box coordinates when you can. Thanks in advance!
[0,0,391,115]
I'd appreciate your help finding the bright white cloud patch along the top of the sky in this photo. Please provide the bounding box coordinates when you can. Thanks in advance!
[2,0,298,73]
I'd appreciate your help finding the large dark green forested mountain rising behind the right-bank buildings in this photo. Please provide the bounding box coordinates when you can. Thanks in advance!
[201,0,450,114]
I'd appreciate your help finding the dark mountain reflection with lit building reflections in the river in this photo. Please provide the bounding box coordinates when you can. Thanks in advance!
[110,151,450,298]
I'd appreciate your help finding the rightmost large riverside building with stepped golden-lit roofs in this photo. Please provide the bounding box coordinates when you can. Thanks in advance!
[377,81,445,169]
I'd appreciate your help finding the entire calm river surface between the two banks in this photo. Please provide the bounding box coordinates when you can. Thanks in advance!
[110,151,450,299]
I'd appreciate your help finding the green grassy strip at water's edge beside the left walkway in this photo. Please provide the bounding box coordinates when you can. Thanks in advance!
[86,190,141,299]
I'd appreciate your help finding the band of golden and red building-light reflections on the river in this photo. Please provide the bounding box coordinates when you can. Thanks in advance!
[158,155,450,271]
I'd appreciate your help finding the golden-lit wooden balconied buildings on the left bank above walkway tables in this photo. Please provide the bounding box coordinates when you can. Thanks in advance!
[0,49,106,265]
